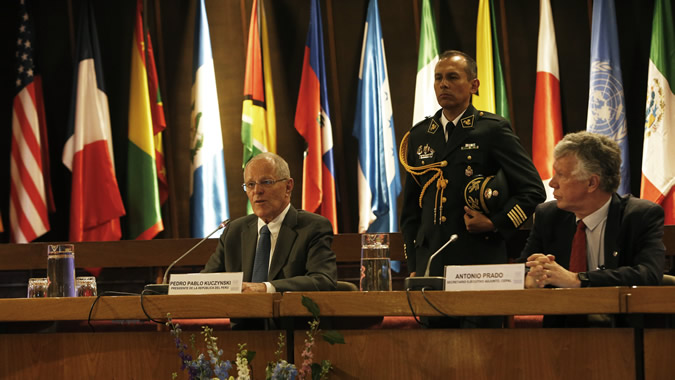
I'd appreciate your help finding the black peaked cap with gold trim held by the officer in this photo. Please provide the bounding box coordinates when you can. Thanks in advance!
[464,170,509,215]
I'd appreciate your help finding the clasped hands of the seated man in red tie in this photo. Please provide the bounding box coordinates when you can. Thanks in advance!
[525,253,581,288]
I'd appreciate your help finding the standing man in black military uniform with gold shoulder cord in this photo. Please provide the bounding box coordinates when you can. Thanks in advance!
[400,50,546,284]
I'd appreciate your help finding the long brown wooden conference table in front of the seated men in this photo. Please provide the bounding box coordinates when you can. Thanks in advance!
[0,287,675,379]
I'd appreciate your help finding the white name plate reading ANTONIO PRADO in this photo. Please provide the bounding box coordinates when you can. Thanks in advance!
[445,264,525,291]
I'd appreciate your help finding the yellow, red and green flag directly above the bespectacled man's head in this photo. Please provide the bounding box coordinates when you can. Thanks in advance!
[241,0,277,166]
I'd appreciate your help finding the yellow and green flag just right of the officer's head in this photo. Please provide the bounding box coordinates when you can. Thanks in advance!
[472,0,509,119]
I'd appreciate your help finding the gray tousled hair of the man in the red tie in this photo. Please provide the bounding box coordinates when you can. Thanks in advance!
[553,131,621,193]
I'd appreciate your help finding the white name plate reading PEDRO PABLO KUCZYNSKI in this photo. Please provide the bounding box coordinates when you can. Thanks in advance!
[169,272,244,295]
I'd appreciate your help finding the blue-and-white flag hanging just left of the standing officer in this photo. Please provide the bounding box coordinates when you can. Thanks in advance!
[352,0,401,233]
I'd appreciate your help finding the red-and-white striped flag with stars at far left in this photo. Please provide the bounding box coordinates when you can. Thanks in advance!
[10,1,54,243]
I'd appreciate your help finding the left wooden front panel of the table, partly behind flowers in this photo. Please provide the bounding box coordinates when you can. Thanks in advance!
[0,331,278,380]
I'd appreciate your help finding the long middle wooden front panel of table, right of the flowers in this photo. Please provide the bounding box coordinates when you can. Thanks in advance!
[295,329,635,380]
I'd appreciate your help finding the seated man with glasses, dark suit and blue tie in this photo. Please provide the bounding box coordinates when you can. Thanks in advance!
[203,153,337,293]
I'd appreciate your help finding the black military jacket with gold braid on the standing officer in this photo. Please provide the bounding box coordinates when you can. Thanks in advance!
[401,105,546,276]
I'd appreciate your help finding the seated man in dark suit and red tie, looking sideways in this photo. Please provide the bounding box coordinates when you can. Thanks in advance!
[521,132,665,288]
